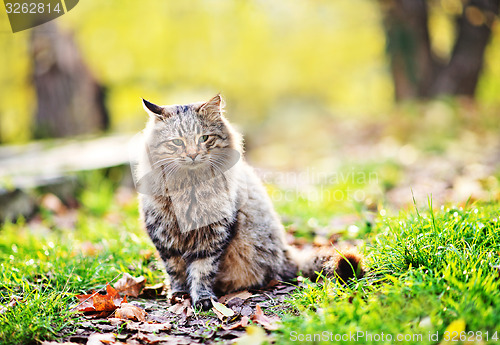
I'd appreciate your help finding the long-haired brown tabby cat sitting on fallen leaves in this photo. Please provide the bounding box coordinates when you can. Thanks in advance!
[137,95,362,310]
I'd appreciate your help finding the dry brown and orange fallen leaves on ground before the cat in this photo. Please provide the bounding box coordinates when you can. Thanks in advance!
[59,274,296,345]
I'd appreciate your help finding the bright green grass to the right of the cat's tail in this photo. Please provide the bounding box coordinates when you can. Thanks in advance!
[278,200,500,344]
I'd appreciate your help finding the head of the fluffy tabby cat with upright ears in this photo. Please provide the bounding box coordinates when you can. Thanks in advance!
[143,95,241,171]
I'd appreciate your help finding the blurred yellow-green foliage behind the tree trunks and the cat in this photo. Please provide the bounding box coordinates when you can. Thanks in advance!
[0,0,500,142]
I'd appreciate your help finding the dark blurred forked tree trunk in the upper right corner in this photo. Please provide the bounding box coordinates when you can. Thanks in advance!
[379,0,500,100]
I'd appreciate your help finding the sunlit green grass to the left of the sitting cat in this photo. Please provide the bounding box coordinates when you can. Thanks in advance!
[0,175,163,344]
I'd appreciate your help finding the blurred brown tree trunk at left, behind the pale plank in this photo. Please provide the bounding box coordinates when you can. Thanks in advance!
[31,22,109,138]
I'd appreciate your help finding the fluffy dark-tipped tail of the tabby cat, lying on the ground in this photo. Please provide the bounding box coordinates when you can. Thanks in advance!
[289,247,365,283]
